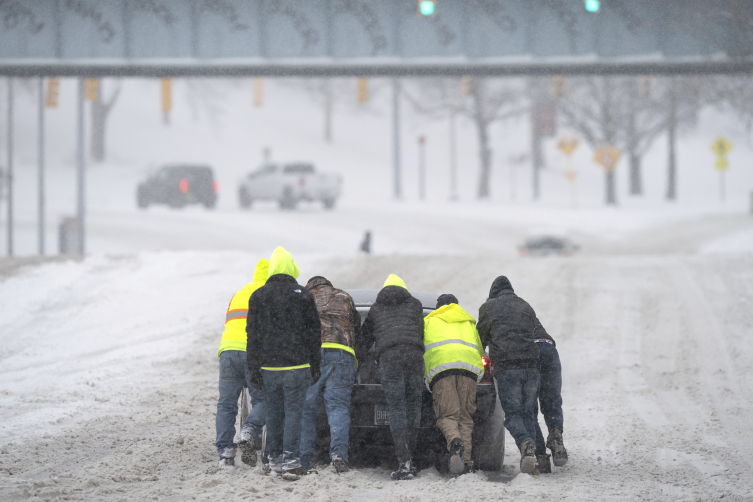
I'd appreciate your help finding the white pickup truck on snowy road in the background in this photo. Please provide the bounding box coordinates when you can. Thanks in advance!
[238,162,342,209]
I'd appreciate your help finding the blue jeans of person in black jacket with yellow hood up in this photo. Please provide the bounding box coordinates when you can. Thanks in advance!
[261,368,311,469]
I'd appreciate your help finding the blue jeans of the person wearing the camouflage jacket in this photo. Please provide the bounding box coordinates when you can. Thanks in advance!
[301,349,356,469]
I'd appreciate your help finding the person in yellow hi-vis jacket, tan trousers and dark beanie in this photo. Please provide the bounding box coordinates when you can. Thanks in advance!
[424,295,484,475]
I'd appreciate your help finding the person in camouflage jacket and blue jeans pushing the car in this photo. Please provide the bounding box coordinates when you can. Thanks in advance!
[301,276,361,472]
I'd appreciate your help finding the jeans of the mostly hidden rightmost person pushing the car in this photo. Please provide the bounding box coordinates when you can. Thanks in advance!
[534,342,564,455]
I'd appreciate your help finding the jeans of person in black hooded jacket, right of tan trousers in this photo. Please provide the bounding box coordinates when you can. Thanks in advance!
[494,368,540,450]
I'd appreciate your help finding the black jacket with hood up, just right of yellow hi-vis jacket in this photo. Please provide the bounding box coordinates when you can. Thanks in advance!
[476,276,551,372]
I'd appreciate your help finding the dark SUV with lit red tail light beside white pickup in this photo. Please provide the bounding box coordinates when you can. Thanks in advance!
[136,164,218,209]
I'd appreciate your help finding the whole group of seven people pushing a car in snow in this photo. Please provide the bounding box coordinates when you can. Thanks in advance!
[215,247,567,481]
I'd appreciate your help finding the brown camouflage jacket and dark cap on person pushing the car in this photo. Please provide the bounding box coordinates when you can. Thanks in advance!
[306,277,361,349]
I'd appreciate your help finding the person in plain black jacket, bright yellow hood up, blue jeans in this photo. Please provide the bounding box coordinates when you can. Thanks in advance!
[246,247,321,481]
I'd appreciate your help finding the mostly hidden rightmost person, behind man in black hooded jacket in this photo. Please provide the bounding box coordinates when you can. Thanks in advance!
[534,328,567,474]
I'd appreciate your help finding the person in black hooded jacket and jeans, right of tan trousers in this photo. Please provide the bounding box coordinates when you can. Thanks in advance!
[477,276,540,473]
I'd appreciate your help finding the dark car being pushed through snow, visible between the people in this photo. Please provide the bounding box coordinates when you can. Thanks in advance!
[262,289,505,472]
